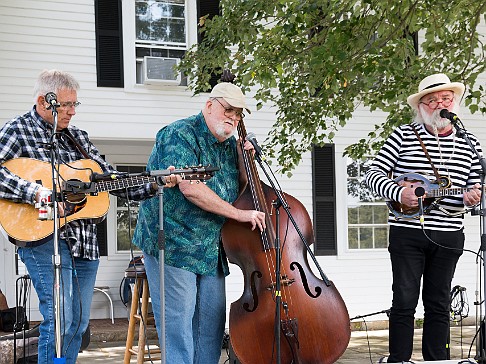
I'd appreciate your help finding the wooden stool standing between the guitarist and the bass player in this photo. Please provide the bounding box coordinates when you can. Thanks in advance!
[123,266,160,364]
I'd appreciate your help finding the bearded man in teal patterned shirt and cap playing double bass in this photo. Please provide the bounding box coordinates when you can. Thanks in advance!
[133,82,265,364]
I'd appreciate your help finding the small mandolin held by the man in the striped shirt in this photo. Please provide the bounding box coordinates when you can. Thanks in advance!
[386,173,478,219]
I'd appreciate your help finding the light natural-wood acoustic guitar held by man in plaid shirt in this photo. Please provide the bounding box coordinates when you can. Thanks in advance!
[0,158,219,246]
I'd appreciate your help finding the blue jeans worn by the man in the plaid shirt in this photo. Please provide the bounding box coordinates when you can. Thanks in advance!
[18,240,99,364]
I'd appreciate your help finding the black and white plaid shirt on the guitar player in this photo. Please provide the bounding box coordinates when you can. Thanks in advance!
[0,106,155,260]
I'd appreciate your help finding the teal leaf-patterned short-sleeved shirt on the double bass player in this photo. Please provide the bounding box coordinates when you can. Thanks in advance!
[133,113,239,275]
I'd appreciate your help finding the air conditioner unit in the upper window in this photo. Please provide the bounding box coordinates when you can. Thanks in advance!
[143,56,181,85]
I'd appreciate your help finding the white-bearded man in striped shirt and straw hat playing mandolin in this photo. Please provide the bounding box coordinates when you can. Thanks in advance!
[366,74,482,363]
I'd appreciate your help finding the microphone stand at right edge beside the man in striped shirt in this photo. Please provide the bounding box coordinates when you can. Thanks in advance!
[451,116,486,363]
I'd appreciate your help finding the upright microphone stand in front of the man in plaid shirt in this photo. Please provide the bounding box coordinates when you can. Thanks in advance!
[49,102,66,364]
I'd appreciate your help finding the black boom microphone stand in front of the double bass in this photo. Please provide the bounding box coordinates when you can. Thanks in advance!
[252,149,331,364]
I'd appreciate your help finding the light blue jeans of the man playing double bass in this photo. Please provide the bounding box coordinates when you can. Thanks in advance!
[144,254,226,364]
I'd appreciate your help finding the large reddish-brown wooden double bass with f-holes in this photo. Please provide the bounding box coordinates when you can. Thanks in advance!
[222,120,351,364]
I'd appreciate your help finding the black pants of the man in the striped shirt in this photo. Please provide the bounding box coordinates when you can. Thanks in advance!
[388,226,464,362]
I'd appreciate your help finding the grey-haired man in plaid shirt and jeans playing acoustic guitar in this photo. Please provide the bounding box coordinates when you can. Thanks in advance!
[0,70,180,364]
